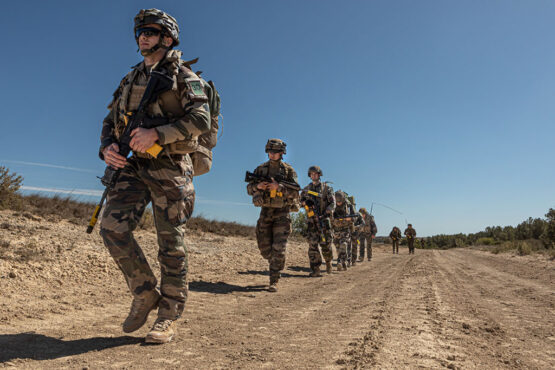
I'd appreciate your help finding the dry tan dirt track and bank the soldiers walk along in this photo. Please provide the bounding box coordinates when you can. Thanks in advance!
[0,212,555,369]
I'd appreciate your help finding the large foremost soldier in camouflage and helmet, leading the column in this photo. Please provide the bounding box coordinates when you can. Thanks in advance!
[99,9,210,343]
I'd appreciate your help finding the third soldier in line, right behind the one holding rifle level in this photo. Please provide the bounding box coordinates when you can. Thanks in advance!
[301,166,335,277]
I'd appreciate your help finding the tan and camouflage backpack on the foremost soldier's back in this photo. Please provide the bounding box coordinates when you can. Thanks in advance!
[183,58,223,176]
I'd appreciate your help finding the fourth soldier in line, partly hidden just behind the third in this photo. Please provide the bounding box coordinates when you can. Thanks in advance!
[333,190,358,271]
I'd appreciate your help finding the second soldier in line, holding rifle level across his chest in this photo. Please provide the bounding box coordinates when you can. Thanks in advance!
[247,139,300,292]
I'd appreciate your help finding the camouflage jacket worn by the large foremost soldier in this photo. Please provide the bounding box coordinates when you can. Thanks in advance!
[100,50,210,159]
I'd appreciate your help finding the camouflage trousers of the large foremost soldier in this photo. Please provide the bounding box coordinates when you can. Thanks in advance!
[100,156,195,320]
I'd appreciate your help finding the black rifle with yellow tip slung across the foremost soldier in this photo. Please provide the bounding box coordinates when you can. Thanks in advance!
[87,71,173,234]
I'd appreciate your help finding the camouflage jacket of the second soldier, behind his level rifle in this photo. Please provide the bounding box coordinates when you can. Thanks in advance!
[247,160,299,210]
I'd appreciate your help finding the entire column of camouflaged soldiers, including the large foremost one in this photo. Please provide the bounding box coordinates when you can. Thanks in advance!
[92,9,416,344]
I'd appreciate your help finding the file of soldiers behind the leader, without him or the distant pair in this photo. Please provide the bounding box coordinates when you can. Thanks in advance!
[245,139,377,284]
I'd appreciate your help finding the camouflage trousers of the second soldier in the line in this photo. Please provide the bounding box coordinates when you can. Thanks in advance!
[256,207,291,278]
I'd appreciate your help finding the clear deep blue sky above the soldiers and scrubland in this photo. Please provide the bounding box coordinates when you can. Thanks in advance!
[0,0,555,235]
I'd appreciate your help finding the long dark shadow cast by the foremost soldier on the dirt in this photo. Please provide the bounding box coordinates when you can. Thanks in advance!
[0,332,143,363]
